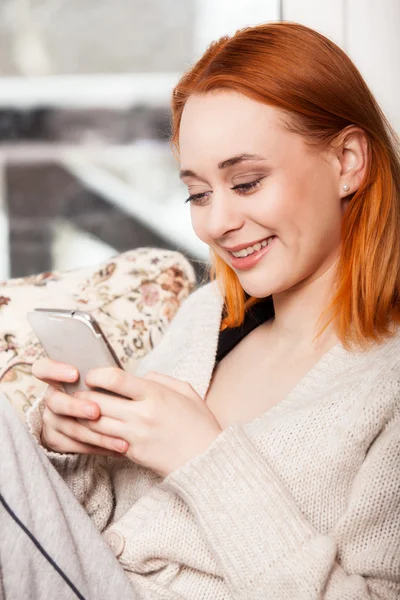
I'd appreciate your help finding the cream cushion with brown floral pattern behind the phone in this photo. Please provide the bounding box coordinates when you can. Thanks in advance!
[0,248,196,422]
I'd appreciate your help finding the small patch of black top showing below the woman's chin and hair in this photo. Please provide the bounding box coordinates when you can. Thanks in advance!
[215,296,275,365]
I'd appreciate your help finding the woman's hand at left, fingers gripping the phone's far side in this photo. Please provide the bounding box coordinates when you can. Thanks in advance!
[32,358,126,457]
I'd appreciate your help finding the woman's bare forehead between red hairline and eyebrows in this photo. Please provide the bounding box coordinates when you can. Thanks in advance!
[179,91,287,163]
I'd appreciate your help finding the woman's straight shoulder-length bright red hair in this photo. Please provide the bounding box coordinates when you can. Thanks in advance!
[171,22,400,349]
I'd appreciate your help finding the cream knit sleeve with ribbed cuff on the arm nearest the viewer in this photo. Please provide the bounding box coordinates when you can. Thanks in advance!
[162,414,400,600]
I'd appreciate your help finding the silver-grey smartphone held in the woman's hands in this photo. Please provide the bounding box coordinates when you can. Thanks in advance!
[26,308,123,394]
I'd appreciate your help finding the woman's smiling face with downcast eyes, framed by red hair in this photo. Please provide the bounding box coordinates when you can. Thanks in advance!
[179,91,343,298]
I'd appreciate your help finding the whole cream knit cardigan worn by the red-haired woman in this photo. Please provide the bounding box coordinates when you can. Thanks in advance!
[27,282,400,600]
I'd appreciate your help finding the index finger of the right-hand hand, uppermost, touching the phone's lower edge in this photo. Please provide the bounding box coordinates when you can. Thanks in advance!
[85,367,148,400]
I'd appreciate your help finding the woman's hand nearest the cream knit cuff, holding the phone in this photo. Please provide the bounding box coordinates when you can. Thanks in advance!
[74,367,222,477]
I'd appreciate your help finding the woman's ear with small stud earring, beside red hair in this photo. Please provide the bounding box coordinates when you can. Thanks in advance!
[335,125,368,198]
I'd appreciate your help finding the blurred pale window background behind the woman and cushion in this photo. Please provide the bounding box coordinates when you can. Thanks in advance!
[0,0,400,280]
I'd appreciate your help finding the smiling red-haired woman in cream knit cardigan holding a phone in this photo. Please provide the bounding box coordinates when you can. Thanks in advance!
[0,22,400,600]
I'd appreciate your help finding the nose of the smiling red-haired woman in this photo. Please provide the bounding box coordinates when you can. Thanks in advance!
[206,191,244,240]
